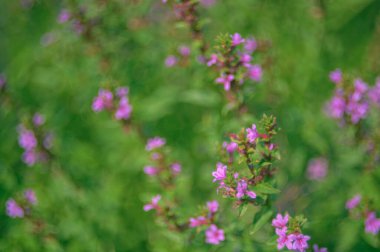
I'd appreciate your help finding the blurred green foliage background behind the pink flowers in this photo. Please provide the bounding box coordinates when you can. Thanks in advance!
[0,0,380,251]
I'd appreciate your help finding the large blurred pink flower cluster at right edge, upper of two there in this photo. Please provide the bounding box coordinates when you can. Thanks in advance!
[326,69,380,124]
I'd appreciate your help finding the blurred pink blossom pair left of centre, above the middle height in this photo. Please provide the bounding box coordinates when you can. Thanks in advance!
[92,87,132,120]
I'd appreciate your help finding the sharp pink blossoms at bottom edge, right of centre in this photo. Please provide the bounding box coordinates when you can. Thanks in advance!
[272,214,310,252]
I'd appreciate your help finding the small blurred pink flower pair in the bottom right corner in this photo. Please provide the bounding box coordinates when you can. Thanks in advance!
[346,194,380,235]
